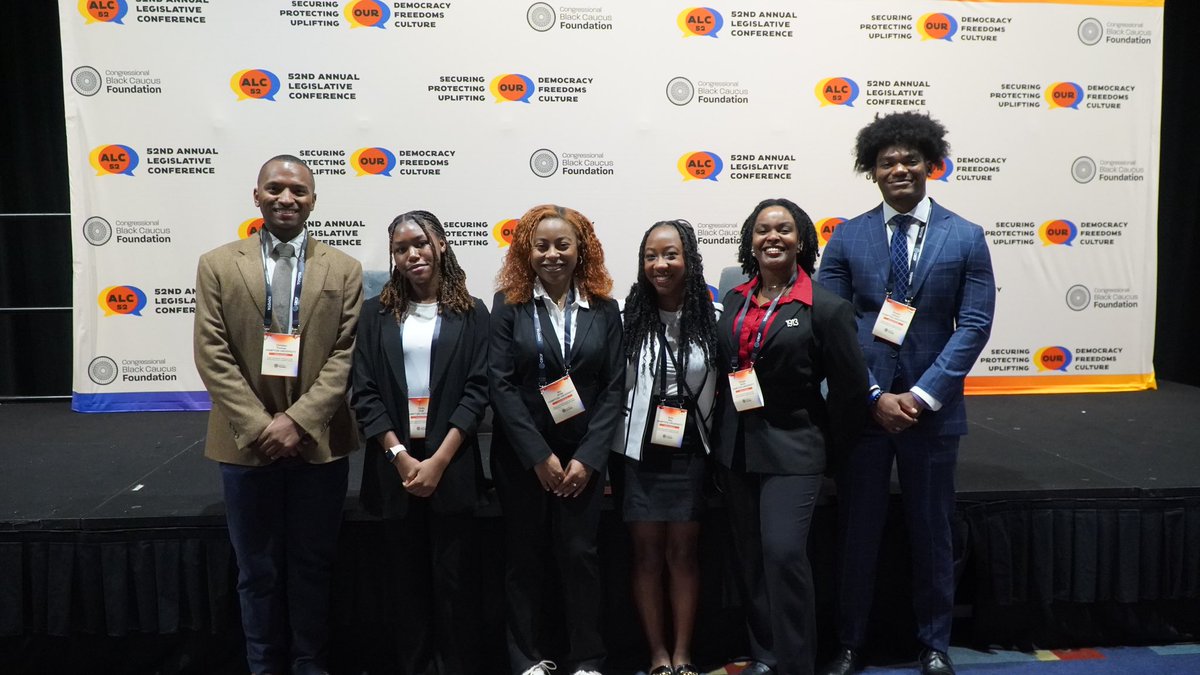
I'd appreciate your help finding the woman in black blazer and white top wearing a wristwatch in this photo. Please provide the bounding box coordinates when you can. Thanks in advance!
[352,211,488,674]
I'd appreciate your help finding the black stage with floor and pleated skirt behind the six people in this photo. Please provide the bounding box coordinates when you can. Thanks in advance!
[0,382,1200,673]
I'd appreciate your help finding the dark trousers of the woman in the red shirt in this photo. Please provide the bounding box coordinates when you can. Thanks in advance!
[719,467,821,675]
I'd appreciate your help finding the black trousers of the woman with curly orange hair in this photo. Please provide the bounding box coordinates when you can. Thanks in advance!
[492,450,606,674]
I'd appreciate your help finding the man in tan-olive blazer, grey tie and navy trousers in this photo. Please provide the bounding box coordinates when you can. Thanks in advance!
[193,155,362,673]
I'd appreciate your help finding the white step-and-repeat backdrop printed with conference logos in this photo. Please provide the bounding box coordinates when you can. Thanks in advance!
[59,0,1163,412]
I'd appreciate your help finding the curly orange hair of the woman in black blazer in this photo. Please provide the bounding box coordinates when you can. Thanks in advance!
[496,204,612,305]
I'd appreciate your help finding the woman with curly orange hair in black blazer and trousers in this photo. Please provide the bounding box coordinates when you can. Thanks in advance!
[488,204,625,675]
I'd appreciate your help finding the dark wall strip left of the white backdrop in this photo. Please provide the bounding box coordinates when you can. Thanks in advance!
[0,2,72,399]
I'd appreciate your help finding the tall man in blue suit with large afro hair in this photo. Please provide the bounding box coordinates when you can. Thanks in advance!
[817,113,996,675]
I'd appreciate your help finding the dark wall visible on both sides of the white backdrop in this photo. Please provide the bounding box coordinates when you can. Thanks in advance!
[0,5,1200,399]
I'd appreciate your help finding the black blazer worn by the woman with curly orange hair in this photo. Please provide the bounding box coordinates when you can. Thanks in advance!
[488,293,625,470]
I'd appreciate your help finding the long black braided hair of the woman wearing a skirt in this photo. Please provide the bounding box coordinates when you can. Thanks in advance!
[624,220,716,372]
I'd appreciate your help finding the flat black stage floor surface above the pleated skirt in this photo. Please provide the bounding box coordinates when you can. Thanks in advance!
[0,382,1200,530]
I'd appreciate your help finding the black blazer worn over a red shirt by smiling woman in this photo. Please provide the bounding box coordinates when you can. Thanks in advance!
[713,275,868,474]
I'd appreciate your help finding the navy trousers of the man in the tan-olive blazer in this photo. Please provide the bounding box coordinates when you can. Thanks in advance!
[221,458,350,674]
